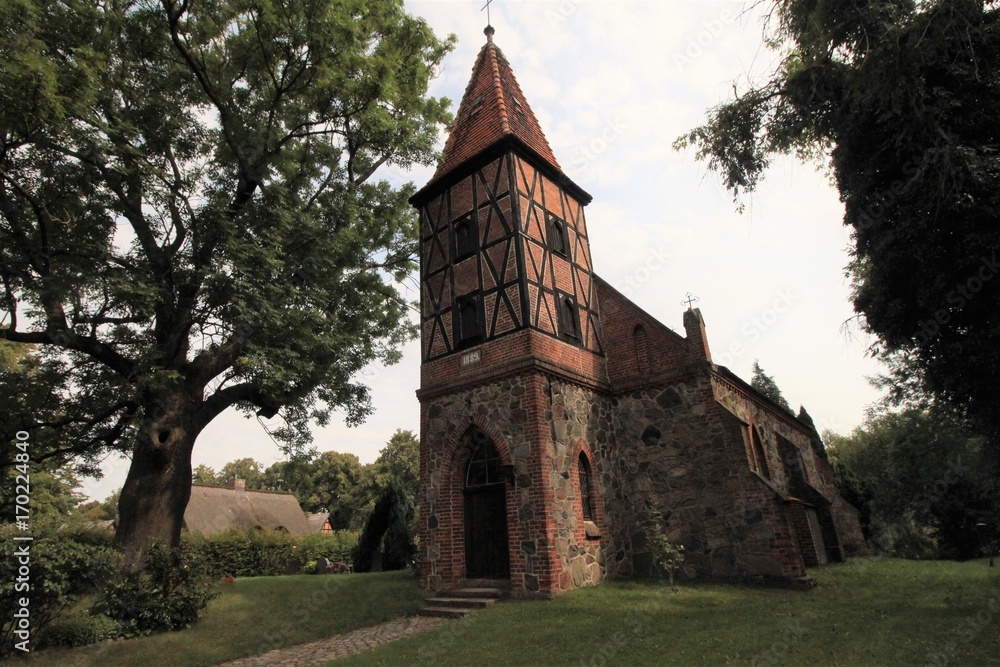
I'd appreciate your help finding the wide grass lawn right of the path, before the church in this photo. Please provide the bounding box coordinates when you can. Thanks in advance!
[335,559,1000,667]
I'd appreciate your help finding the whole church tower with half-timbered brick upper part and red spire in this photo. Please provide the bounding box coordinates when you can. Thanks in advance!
[411,26,607,596]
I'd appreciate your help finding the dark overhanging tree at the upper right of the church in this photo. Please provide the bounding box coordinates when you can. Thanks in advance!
[677,0,1000,471]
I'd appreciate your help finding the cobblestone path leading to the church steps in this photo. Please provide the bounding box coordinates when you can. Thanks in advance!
[222,616,448,667]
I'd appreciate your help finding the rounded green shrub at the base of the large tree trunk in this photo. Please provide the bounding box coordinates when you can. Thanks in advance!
[91,544,219,636]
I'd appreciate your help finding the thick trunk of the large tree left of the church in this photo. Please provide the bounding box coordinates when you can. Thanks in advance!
[115,392,204,568]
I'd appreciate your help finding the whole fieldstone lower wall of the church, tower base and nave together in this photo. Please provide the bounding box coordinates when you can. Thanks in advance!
[421,358,864,596]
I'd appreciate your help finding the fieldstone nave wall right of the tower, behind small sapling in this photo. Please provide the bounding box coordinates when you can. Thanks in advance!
[608,374,804,579]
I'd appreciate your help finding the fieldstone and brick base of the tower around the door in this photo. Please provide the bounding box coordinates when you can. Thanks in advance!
[420,372,607,595]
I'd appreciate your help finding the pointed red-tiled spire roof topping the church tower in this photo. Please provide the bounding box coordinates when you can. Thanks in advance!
[431,26,562,182]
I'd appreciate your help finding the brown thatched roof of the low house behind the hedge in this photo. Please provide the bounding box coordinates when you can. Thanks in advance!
[184,479,310,535]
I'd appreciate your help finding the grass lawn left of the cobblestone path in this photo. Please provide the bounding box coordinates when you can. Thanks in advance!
[12,572,425,667]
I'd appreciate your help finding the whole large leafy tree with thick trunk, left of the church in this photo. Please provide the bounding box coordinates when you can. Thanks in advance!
[0,0,450,563]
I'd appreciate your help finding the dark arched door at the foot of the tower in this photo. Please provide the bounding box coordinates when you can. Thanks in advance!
[465,427,510,579]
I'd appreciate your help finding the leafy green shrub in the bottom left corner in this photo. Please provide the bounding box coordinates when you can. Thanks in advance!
[0,531,115,656]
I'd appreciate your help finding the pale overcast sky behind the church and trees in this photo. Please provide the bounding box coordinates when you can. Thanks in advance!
[83,0,878,499]
